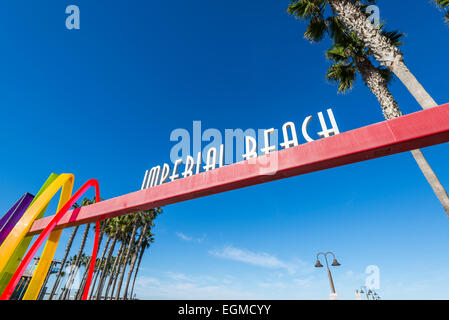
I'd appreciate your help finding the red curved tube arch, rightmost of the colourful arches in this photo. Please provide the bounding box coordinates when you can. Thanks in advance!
[0,179,100,300]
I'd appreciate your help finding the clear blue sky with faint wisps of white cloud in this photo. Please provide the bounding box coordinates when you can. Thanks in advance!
[0,0,449,299]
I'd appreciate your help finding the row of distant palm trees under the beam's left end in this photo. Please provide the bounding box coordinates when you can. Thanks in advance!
[43,198,162,300]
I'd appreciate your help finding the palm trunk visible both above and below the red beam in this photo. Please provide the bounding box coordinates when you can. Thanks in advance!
[356,58,449,216]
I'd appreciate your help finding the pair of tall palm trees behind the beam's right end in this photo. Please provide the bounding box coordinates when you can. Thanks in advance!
[287,0,449,216]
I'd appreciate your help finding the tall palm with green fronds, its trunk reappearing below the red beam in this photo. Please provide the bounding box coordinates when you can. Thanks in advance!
[287,0,449,216]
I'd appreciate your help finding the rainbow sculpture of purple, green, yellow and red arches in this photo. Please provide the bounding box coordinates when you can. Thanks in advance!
[0,173,100,300]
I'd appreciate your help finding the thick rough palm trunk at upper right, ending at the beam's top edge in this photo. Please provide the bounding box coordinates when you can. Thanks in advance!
[329,0,437,109]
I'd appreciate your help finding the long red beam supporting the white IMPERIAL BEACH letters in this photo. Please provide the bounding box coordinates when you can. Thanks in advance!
[29,104,449,235]
